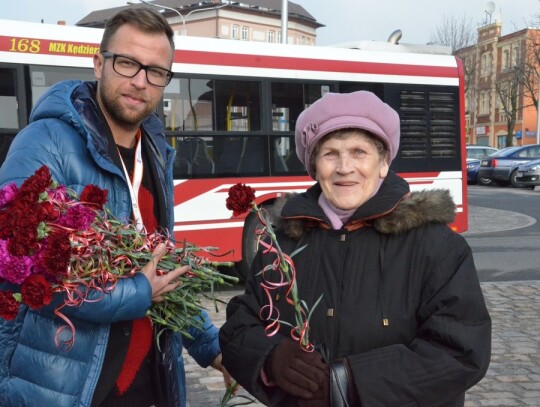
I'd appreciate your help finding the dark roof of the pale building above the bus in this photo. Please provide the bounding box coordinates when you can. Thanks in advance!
[75,0,324,28]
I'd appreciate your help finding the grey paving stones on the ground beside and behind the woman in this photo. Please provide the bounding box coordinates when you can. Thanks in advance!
[185,281,540,407]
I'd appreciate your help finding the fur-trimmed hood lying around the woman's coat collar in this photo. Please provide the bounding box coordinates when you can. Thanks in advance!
[271,174,456,239]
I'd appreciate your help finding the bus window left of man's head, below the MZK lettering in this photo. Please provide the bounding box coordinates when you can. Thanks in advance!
[30,65,95,106]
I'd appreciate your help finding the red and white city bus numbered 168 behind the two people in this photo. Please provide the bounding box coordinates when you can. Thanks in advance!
[0,20,468,278]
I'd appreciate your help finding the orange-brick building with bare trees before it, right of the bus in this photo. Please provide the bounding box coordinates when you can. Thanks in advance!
[456,21,540,148]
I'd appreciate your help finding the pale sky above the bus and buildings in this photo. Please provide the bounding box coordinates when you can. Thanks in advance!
[0,0,540,45]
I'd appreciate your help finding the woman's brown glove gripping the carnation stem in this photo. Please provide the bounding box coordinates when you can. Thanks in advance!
[265,339,330,399]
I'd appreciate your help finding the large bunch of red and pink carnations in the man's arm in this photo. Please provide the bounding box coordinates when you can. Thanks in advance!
[0,166,237,349]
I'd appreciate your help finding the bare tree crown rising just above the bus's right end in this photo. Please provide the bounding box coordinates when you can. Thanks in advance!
[430,14,478,53]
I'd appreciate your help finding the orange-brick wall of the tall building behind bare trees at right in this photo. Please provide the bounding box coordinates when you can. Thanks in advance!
[457,22,540,148]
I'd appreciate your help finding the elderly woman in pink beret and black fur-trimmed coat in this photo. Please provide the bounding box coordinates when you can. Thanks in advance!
[220,91,491,407]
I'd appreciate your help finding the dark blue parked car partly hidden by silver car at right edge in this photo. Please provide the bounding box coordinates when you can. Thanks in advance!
[478,144,540,187]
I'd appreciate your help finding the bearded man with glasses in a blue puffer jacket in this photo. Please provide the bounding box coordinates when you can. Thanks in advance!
[0,9,230,407]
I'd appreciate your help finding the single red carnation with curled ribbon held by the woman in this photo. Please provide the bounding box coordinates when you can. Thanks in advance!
[225,184,322,352]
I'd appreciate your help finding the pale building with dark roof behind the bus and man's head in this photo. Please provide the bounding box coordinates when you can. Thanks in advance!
[76,0,324,45]
